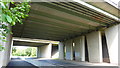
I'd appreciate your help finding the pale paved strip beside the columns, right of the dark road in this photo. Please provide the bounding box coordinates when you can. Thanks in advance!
[26,59,118,68]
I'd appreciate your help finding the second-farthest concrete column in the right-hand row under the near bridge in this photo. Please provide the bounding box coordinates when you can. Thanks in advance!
[65,40,73,60]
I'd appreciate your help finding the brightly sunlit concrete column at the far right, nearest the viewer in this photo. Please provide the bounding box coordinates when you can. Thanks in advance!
[105,25,120,64]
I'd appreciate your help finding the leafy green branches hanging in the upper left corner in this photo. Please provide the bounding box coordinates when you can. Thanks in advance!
[0,0,30,51]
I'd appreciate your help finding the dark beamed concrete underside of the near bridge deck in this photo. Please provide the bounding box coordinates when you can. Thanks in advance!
[13,2,119,41]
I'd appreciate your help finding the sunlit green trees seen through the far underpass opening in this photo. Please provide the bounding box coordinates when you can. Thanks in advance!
[12,47,37,57]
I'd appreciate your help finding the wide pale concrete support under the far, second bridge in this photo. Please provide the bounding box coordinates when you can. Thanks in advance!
[37,43,52,58]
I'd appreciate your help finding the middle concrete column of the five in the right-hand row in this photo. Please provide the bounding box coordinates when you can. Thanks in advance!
[74,36,85,61]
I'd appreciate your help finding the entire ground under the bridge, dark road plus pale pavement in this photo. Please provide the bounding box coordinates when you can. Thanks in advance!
[6,58,118,68]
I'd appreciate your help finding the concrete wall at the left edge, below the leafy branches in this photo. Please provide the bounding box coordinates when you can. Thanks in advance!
[0,26,12,68]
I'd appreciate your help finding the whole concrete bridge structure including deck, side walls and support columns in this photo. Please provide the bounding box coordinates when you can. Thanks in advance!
[0,2,120,66]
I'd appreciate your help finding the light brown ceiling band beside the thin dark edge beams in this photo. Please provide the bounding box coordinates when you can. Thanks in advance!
[31,4,99,28]
